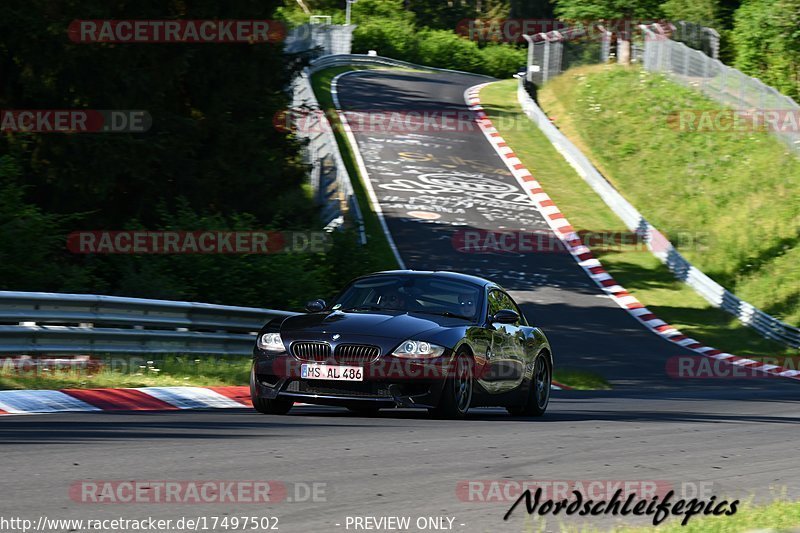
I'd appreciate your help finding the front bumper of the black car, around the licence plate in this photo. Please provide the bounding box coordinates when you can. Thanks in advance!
[251,355,450,408]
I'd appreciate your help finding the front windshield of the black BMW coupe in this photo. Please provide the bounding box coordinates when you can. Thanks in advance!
[333,276,481,321]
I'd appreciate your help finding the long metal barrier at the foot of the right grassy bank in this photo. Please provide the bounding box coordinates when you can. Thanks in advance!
[517,77,800,348]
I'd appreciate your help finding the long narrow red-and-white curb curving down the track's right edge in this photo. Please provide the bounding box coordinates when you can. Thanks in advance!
[464,83,800,380]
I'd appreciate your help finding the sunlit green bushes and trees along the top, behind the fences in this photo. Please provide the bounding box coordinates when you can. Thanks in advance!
[279,0,800,99]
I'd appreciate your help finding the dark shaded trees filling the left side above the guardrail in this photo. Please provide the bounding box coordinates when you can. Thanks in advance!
[0,0,378,307]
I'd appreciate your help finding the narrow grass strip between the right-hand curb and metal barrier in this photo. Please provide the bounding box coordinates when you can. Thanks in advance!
[481,79,797,358]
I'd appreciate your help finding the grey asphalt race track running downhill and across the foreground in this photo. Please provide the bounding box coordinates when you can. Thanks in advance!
[0,71,800,532]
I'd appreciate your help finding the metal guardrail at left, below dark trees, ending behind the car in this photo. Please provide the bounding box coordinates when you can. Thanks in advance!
[0,291,297,355]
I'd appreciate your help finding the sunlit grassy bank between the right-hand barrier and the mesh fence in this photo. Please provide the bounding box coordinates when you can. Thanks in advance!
[539,65,800,325]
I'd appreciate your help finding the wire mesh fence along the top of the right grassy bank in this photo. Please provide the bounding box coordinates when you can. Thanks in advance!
[642,24,800,156]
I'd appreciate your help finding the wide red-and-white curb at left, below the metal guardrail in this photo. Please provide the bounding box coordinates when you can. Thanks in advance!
[0,382,569,416]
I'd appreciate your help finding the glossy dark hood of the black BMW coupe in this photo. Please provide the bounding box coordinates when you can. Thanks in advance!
[281,311,446,342]
